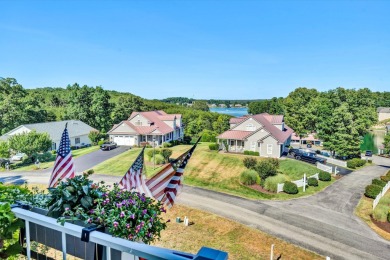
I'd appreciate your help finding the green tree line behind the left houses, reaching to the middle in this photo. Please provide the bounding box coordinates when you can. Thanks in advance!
[0,78,231,139]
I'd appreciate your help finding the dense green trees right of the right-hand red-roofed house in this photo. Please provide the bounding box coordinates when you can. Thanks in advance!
[249,87,390,156]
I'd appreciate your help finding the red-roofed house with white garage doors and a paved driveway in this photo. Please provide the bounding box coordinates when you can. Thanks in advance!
[108,110,184,146]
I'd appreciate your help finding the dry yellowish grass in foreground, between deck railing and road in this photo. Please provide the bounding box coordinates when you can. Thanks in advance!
[154,204,324,259]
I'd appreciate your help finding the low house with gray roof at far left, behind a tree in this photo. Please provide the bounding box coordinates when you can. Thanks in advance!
[0,120,97,150]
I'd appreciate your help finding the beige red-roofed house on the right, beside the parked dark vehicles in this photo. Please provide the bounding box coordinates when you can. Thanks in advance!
[217,113,294,158]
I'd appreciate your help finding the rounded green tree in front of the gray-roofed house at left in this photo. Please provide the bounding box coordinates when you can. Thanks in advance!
[8,130,52,158]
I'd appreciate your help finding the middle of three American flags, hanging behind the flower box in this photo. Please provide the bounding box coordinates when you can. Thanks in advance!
[119,147,149,194]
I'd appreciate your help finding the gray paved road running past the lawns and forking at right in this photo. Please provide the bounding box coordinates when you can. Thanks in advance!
[0,157,390,259]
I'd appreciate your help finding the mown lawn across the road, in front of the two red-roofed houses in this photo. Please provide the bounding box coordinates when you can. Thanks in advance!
[93,143,335,199]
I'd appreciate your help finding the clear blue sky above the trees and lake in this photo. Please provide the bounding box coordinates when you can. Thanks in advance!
[0,0,390,99]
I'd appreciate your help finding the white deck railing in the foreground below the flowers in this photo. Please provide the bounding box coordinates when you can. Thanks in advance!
[12,207,228,260]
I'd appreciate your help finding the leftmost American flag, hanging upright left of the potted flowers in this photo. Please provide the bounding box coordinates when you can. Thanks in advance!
[49,123,75,188]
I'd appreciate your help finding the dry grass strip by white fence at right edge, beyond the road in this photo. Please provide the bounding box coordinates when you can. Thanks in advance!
[355,192,390,240]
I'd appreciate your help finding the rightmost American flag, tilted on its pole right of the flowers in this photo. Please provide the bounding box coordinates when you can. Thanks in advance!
[145,138,200,208]
